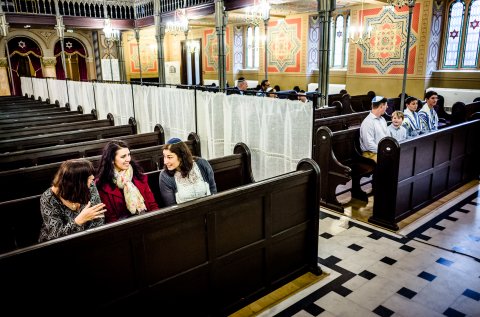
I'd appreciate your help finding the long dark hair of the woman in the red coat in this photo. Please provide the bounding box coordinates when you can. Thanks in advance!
[96,140,143,188]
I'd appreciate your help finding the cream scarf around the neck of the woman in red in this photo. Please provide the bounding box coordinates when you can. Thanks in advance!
[113,166,147,215]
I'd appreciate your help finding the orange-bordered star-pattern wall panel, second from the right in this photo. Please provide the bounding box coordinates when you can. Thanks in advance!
[267,18,302,73]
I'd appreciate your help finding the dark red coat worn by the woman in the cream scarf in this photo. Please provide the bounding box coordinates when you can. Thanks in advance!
[98,175,159,223]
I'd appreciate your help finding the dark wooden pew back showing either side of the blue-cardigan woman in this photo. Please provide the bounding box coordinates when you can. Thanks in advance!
[146,143,254,207]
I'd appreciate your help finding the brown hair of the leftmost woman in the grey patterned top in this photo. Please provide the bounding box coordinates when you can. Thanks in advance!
[52,159,95,204]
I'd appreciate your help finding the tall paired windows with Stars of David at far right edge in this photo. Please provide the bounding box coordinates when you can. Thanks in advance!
[442,0,480,69]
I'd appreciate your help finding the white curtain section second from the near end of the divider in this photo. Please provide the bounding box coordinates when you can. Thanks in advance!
[133,85,196,140]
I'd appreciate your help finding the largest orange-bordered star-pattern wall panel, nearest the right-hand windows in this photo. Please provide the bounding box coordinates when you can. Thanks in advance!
[355,3,420,74]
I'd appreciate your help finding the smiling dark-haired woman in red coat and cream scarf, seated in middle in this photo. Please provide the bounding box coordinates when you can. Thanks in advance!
[96,140,159,223]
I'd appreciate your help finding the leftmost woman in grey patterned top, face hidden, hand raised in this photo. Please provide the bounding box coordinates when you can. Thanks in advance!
[38,159,105,242]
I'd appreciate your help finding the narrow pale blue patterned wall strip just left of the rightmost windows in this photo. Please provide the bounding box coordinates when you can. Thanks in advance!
[426,1,444,75]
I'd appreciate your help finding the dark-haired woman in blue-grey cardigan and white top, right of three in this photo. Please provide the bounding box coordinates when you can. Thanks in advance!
[159,138,217,206]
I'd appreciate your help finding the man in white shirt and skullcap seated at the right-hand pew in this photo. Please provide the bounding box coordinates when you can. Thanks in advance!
[360,96,390,162]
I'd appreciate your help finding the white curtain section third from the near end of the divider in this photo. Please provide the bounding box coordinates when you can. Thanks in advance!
[94,83,133,125]
